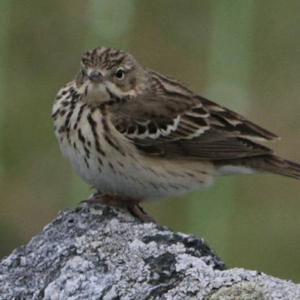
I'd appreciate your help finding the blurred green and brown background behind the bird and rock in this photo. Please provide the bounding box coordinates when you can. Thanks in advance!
[0,0,300,281]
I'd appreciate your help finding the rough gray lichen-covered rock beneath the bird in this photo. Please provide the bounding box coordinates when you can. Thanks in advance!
[0,204,300,300]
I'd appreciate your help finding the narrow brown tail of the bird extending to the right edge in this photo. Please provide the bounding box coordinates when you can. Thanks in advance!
[217,154,300,179]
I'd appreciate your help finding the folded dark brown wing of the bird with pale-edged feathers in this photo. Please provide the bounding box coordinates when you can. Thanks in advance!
[112,75,277,160]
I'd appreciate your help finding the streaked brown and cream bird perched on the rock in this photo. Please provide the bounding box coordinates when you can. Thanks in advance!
[52,47,300,222]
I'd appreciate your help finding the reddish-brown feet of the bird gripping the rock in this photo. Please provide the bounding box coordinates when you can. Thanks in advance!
[81,192,156,223]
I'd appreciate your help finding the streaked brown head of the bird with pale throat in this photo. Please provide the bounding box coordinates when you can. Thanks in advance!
[76,47,147,105]
